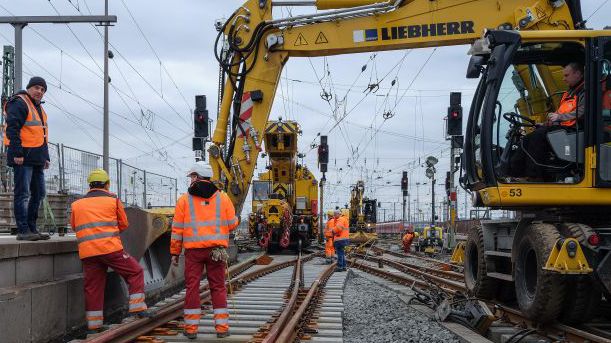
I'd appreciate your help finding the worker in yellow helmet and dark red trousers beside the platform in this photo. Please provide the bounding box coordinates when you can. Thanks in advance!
[70,169,153,333]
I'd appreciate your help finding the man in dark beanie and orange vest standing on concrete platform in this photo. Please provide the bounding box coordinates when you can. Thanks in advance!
[3,76,50,241]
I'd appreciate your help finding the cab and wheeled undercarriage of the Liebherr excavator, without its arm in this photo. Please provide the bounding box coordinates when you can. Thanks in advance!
[463,30,611,323]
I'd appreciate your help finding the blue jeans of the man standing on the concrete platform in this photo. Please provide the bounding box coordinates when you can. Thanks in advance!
[13,165,46,234]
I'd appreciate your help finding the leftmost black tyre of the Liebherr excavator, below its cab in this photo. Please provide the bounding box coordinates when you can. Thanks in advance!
[464,226,498,299]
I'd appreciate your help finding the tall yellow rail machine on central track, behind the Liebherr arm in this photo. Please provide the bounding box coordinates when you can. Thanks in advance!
[248,119,318,251]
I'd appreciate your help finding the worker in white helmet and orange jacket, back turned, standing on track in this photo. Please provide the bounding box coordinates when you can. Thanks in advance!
[170,161,238,339]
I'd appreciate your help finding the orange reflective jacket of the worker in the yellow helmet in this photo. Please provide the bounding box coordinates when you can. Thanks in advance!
[70,189,129,259]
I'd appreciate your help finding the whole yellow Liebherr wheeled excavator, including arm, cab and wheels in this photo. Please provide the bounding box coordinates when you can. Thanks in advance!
[209,0,611,322]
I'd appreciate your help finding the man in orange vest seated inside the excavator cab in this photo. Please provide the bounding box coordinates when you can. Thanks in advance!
[512,62,585,182]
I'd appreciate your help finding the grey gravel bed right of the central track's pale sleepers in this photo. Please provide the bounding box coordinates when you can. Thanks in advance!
[344,272,460,343]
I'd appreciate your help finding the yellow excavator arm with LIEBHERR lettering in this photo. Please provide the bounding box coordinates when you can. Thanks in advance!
[213,0,582,213]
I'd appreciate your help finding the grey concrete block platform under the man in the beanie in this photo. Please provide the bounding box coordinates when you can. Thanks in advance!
[0,235,85,342]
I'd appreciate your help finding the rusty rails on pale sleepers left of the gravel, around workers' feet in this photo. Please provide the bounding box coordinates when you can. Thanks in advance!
[80,254,347,343]
